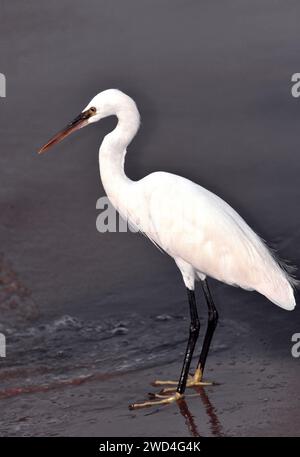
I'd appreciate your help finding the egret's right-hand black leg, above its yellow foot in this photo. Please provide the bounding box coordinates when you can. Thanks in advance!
[197,279,219,377]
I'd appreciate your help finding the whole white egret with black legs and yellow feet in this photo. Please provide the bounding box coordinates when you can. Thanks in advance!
[39,89,296,407]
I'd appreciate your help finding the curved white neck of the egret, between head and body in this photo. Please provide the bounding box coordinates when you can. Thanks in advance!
[99,97,140,213]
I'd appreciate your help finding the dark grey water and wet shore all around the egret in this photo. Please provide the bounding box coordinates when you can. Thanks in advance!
[0,0,300,436]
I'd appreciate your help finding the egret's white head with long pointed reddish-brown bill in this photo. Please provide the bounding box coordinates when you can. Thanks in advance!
[38,89,136,154]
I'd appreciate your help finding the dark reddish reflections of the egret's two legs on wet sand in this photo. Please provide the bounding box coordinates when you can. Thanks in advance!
[177,387,223,437]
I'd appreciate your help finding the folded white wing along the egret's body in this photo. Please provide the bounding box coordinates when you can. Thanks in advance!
[140,172,293,308]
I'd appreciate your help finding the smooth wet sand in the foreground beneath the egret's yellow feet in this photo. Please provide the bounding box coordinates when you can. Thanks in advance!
[1,361,300,437]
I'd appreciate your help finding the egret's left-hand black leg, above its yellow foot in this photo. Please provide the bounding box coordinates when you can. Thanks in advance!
[177,289,200,394]
